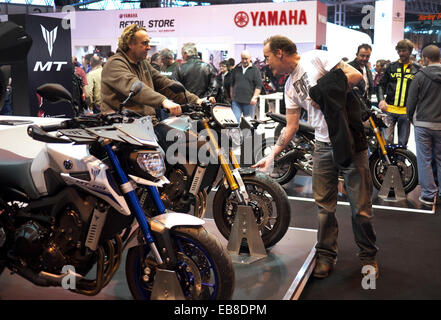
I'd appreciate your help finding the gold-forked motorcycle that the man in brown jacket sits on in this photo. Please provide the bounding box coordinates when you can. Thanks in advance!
[151,85,291,248]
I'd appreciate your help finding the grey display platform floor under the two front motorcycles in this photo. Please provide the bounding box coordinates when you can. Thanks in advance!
[0,219,317,300]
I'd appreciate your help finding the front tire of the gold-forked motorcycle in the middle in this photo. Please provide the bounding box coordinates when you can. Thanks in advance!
[213,173,291,248]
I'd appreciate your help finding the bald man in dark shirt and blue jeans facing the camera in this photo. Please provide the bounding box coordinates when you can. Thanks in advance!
[230,50,262,122]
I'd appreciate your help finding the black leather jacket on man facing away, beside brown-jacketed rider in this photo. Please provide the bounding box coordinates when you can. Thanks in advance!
[172,56,217,98]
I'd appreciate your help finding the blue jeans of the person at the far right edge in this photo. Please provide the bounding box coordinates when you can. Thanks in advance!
[415,127,441,199]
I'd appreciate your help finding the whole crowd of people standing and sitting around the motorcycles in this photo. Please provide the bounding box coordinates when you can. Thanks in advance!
[1,21,441,278]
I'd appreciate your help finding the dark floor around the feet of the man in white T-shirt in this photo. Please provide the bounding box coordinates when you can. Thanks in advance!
[284,176,441,300]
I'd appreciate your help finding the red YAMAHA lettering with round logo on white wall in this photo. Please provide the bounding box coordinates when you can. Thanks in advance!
[234,9,308,28]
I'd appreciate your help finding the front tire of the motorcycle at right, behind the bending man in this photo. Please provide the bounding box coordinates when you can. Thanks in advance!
[369,148,418,194]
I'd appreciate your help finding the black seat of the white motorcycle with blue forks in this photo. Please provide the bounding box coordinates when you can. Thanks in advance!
[0,149,38,198]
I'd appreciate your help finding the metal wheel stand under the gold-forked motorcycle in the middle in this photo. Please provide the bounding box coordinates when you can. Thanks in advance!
[227,205,267,264]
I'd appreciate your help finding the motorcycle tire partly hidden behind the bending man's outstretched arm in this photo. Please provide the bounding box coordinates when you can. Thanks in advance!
[254,138,297,185]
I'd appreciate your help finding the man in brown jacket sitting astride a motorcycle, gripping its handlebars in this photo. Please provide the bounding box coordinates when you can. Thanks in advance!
[101,24,200,121]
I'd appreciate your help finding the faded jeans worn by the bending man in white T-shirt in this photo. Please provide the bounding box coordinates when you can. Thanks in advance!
[312,141,378,264]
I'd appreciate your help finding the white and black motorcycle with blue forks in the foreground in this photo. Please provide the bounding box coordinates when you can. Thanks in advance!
[0,84,234,299]
